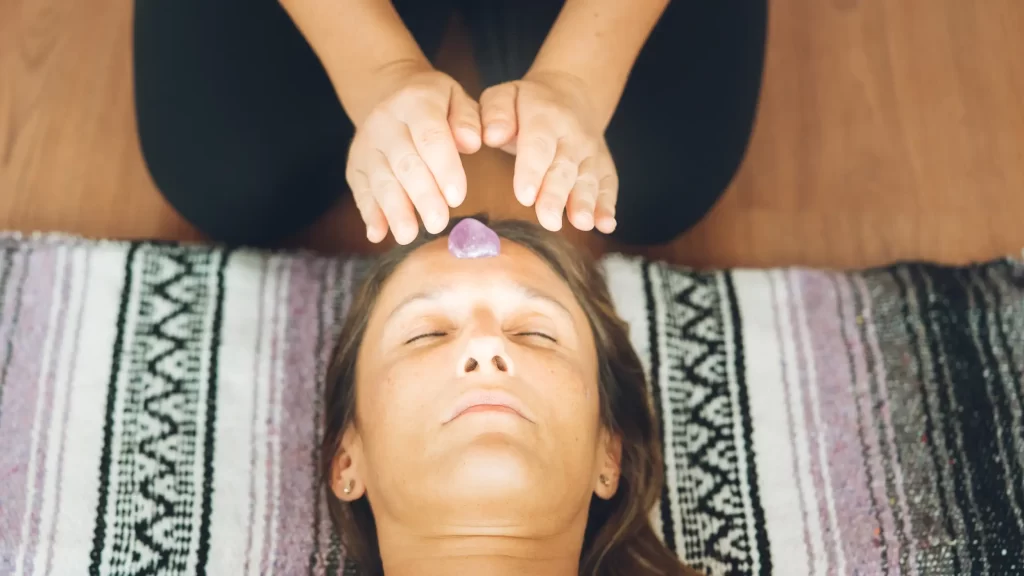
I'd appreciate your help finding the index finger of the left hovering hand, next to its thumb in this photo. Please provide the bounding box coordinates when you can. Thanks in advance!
[406,105,466,207]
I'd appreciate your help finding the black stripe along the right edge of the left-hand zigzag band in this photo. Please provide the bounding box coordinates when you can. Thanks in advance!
[196,245,232,575]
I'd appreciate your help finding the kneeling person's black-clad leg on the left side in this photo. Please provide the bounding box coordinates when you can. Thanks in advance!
[134,0,451,245]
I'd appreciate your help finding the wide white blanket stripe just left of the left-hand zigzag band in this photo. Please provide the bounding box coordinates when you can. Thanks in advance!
[50,243,127,575]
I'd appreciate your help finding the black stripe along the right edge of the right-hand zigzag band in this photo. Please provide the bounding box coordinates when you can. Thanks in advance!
[723,272,772,576]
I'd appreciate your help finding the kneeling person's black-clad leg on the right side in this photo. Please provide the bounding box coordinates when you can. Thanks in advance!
[463,0,768,244]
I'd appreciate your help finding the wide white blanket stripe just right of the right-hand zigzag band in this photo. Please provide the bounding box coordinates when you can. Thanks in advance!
[732,271,807,576]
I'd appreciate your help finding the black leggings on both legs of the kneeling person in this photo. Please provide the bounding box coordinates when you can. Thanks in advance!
[134,0,767,245]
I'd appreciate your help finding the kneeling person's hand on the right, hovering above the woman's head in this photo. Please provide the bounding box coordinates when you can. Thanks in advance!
[480,72,618,234]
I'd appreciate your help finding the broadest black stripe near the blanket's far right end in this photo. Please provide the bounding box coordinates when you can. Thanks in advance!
[944,270,1024,573]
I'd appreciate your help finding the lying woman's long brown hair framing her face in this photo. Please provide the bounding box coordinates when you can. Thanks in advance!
[321,216,695,576]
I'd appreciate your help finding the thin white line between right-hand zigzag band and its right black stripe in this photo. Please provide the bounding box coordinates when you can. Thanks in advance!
[716,273,764,574]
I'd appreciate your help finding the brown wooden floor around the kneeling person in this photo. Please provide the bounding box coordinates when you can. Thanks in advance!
[0,0,1024,268]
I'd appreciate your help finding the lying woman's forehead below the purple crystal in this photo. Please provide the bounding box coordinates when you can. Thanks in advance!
[375,239,583,315]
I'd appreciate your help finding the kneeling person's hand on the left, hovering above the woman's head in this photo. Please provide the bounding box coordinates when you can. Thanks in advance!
[345,66,481,244]
